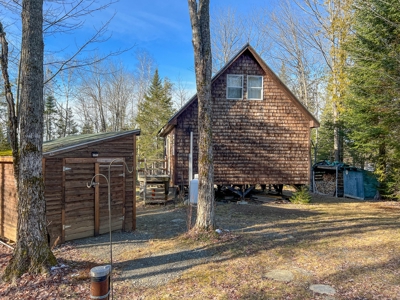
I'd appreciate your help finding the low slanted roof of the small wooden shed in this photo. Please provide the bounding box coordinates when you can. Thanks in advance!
[42,129,140,156]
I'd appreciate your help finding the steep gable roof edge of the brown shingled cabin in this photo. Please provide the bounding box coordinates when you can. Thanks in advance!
[158,44,320,136]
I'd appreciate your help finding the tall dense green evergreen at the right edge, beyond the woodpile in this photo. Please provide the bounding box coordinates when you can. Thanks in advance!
[345,0,400,199]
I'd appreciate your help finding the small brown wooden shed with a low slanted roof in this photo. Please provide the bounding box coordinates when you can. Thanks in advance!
[0,130,140,245]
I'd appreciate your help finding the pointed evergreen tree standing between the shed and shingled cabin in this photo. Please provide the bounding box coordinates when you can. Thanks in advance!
[136,70,173,159]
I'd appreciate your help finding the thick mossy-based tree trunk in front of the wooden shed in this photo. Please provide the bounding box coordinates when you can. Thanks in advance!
[3,0,56,280]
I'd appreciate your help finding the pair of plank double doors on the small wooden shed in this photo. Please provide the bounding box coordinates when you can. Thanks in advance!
[62,158,125,241]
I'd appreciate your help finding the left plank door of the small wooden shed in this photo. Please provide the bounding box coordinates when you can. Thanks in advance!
[63,161,95,241]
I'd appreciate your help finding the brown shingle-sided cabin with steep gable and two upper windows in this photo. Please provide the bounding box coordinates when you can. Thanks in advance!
[159,45,319,190]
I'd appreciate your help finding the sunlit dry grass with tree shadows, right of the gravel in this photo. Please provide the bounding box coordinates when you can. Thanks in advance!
[126,195,400,299]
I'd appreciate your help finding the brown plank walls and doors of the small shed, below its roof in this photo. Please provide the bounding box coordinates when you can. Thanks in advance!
[0,135,136,245]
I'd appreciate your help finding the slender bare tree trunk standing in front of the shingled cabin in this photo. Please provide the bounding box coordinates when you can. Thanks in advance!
[188,0,215,230]
